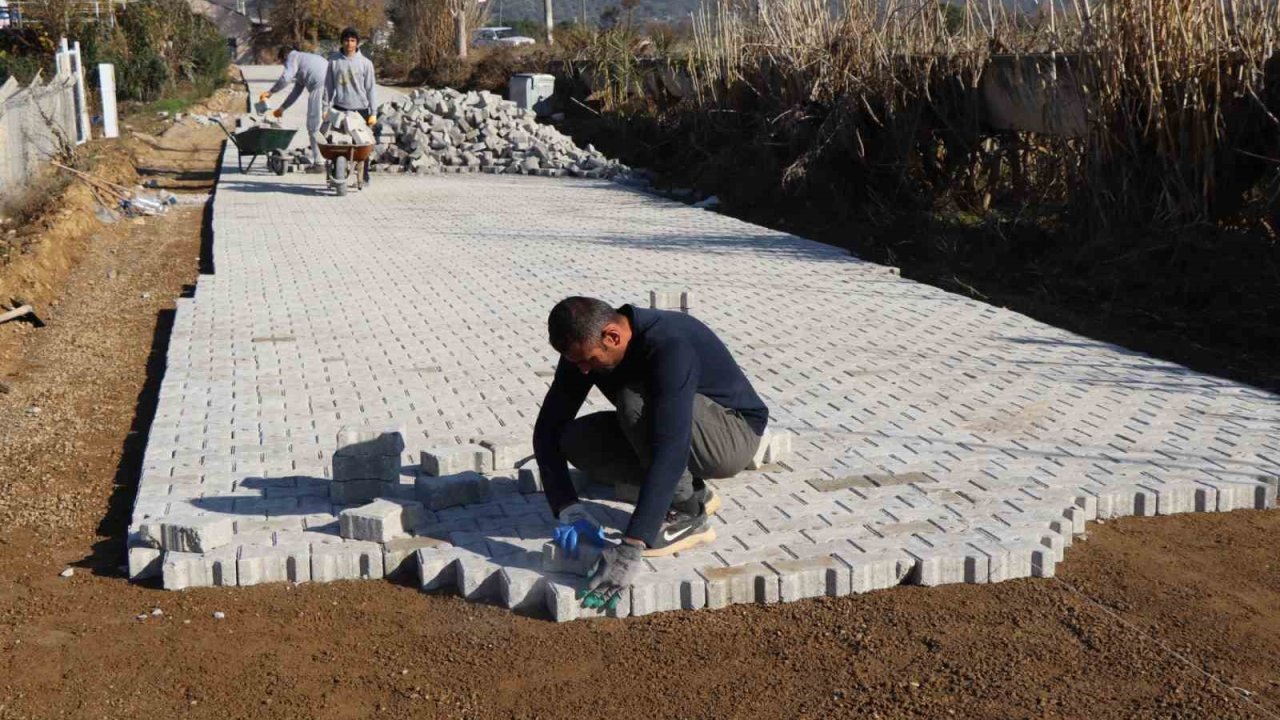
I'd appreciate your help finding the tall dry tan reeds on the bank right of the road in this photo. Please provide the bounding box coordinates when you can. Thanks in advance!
[675,0,1280,232]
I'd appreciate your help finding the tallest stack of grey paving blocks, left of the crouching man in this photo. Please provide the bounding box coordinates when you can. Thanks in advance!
[329,427,404,505]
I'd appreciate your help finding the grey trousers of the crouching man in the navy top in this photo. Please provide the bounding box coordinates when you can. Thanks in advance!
[561,387,760,507]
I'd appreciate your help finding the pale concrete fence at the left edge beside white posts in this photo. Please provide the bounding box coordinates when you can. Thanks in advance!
[0,76,76,197]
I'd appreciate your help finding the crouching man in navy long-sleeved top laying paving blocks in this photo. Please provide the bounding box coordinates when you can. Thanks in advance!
[534,297,769,607]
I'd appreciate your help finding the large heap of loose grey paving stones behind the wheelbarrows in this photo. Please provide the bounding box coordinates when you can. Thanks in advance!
[376,88,631,179]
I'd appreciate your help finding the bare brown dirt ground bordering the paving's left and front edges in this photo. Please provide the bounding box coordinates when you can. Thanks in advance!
[0,82,1280,720]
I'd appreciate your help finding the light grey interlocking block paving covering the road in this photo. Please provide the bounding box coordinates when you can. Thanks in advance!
[131,65,1280,619]
